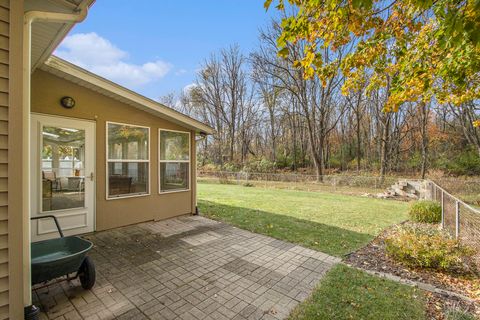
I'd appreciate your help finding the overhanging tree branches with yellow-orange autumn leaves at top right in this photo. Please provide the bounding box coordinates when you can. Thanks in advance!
[265,0,480,115]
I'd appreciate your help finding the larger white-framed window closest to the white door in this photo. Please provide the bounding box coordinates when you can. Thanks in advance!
[107,122,150,199]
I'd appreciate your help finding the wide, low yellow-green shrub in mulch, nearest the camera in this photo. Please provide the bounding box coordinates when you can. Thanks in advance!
[385,225,475,273]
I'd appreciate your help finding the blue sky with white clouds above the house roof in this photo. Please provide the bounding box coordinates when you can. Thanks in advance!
[56,0,275,99]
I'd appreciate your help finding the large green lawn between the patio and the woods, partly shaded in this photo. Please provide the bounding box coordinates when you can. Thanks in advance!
[198,183,408,256]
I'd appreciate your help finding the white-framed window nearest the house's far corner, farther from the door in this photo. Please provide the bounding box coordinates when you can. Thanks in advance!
[158,130,190,193]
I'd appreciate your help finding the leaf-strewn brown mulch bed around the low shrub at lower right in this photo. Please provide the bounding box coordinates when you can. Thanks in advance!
[344,222,480,319]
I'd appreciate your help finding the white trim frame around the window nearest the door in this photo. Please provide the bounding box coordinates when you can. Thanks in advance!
[105,121,152,200]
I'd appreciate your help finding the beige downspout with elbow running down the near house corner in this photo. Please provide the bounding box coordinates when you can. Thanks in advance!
[22,6,88,319]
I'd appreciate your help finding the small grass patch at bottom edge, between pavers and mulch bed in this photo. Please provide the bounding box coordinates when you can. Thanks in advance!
[290,265,426,320]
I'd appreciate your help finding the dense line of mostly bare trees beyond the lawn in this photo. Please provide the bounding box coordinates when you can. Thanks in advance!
[162,23,480,179]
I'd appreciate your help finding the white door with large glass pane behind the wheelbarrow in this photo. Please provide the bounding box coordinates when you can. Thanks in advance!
[30,114,95,241]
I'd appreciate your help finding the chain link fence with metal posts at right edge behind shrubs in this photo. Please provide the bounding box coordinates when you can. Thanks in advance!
[426,181,480,261]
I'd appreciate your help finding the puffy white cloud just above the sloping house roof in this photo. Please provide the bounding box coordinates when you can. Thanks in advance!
[55,32,173,88]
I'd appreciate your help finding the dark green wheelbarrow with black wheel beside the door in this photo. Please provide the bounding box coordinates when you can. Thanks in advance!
[31,215,95,290]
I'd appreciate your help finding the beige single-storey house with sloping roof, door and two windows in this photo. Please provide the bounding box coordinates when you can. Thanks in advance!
[0,0,212,319]
